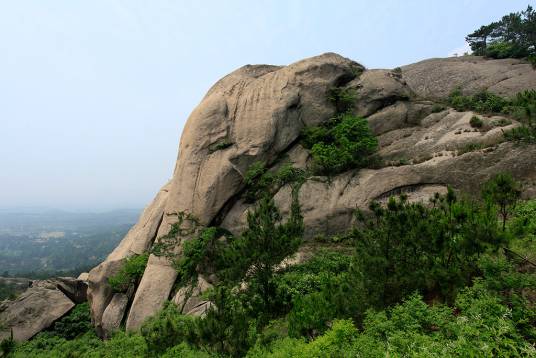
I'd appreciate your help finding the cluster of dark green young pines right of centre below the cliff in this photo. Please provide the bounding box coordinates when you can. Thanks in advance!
[353,190,504,307]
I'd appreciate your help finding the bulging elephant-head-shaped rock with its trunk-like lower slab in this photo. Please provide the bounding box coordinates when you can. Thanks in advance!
[126,54,363,329]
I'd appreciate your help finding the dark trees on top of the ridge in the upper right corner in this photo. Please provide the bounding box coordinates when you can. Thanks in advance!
[466,6,536,65]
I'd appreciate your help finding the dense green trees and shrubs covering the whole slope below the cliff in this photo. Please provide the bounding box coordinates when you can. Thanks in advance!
[4,171,536,357]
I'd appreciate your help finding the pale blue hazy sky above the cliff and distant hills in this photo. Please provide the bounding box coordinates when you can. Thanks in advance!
[0,0,534,210]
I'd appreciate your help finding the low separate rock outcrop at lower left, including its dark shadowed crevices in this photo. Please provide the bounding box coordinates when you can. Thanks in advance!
[0,277,87,342]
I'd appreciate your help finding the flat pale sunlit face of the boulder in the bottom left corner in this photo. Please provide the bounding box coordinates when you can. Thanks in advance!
[0,285,74,342]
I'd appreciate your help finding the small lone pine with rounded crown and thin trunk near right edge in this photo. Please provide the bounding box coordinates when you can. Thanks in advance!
[482,173,521,231]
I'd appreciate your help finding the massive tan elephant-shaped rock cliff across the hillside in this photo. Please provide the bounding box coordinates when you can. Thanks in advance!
[88,53,536,334]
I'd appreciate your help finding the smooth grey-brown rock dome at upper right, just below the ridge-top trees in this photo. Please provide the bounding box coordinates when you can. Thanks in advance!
[402,56,536,99]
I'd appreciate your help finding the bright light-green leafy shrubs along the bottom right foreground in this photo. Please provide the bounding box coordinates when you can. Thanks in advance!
[252,285,536,357]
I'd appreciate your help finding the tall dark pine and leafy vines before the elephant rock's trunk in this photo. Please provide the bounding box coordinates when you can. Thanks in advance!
[163,178,303,355]
